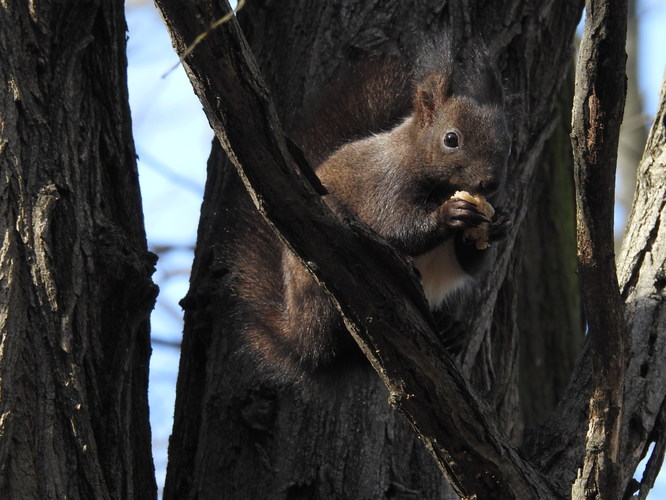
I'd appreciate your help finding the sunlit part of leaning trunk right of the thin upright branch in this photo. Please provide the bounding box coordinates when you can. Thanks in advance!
[618,74,666,497]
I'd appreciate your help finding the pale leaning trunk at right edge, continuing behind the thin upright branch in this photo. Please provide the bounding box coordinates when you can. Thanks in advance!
[524,67,666,498]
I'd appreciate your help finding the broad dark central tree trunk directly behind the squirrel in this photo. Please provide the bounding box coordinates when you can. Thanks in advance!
[165,1,582,498]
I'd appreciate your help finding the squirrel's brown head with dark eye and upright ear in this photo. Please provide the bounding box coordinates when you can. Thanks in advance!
[411,73,511,200]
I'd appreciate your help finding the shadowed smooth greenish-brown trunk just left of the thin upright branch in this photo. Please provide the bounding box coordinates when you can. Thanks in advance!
[517,67,585,428]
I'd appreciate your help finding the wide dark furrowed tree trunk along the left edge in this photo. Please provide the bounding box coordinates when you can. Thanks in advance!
[0,0,157,499]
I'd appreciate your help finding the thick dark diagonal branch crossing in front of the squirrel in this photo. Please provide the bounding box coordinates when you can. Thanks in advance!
[157,0,557,499]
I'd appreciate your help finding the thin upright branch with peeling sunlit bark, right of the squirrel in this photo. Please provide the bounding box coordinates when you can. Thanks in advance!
[572,0,628,498]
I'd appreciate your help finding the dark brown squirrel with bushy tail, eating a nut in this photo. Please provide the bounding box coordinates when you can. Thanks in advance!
[232,38,511,381]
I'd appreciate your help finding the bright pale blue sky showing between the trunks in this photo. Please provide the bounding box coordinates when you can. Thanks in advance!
[127,0,666,500]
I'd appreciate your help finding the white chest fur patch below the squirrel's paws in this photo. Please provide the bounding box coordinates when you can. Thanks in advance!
[414,241,471,310]
